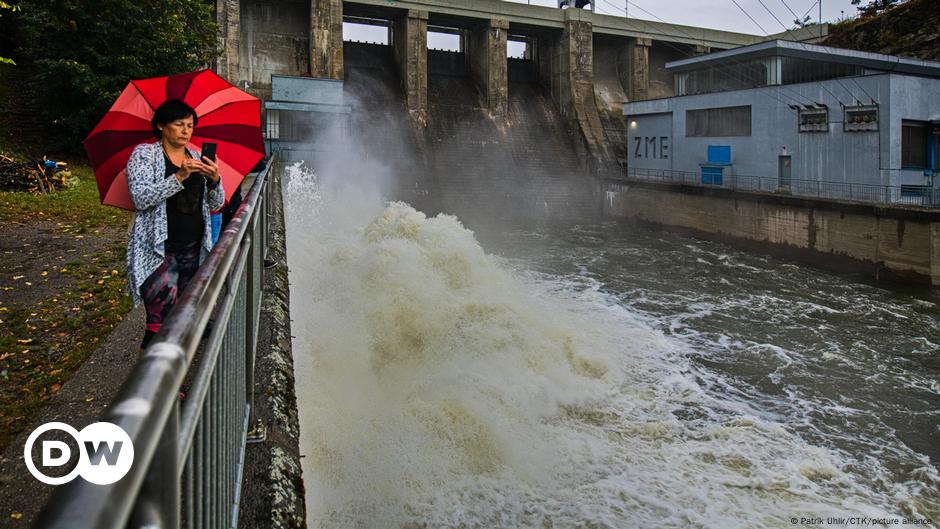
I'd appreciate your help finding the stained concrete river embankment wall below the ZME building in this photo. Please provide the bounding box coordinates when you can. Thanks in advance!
[604,178,940,286]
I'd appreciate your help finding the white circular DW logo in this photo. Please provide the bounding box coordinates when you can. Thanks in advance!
[23,422,134,485]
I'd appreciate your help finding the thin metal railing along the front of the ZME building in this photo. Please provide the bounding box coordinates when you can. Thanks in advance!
[623,168,940,208]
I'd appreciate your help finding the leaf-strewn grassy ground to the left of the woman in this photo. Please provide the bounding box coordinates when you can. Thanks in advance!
[0,163,131,449]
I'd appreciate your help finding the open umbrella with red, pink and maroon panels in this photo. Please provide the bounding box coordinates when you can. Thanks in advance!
[85,70,264,210]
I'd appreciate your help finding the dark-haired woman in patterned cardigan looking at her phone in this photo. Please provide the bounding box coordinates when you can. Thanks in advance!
[127,99,225,349]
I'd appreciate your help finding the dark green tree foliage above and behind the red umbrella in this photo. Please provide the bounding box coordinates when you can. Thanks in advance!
[11,0,219,149]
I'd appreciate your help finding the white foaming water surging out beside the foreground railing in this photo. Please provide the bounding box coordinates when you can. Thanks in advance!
[287,165,935,528]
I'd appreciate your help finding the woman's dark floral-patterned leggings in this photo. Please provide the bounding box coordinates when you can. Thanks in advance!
[140,241,199,348]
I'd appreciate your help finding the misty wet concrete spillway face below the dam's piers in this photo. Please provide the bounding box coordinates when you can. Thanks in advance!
[344,42,600,224]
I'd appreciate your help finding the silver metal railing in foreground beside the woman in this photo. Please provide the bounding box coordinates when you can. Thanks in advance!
[34,154,276,529]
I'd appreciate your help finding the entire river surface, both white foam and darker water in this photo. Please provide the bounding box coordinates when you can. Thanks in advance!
[286,168,940,529]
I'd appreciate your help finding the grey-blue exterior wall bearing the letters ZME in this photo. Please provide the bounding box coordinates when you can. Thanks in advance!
[624,74,940,190]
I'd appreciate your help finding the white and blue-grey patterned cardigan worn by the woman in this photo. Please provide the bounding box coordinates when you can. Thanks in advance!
[127,142,225,306]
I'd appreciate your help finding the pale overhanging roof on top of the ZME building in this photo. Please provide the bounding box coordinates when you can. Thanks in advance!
[666,40,940,77]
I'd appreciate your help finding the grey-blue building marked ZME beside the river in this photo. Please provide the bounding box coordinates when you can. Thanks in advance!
[623,40,940,203]
